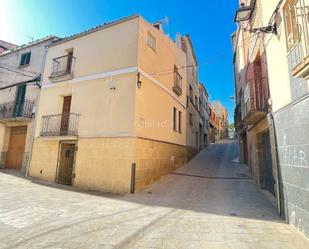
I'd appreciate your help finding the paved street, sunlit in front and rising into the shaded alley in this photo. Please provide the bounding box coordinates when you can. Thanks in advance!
[0,141,309,249]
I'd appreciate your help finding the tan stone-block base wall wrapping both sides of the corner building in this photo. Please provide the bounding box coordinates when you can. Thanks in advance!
[29,138,198,193]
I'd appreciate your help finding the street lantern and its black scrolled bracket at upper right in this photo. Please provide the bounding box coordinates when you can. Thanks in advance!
[234,3,277,34]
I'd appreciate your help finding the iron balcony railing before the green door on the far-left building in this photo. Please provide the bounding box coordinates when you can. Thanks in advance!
[0,100,34,120]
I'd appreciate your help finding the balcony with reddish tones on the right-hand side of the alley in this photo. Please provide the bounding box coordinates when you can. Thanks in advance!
[241,78,269,125]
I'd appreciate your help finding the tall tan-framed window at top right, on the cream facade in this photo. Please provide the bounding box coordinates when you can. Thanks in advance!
[283,0,301,50]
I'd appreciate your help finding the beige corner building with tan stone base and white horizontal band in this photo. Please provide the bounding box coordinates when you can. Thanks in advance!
[29,15,201,193]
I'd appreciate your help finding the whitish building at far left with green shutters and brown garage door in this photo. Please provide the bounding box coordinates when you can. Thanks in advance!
[0,37,57,173]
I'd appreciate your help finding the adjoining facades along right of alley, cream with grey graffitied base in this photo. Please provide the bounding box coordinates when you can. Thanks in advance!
[233,0,309,237]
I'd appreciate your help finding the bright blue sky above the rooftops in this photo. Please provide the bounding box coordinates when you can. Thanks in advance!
[0,0,238,121]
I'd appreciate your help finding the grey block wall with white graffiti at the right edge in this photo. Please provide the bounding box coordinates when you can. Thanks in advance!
[274,97,309,237]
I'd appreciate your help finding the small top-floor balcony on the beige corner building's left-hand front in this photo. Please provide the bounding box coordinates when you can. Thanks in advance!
[49,55,76,82]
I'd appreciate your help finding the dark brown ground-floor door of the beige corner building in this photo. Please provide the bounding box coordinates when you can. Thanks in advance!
[57,143,75,185]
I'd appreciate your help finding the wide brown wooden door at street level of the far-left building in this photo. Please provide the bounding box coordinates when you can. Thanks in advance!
[5,126,27,170]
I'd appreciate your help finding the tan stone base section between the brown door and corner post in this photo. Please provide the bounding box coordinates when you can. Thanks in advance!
[73,138,134,193]
